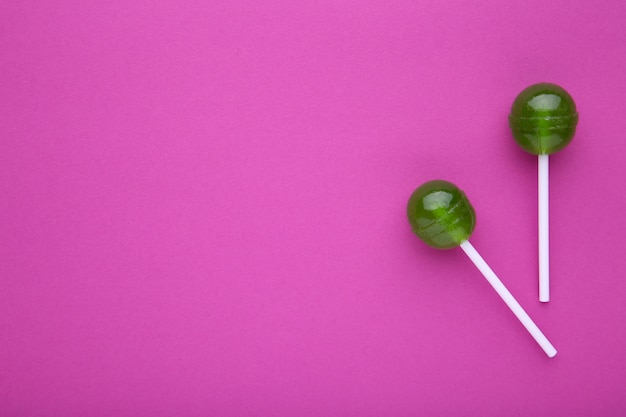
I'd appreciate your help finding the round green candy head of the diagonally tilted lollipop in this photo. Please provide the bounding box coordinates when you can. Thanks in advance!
[406,180,476,249]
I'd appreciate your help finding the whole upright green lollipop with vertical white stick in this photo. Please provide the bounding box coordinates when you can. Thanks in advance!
[509,83,578,302]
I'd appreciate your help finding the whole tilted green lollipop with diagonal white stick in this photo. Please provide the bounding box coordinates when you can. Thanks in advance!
[407,180,556,357]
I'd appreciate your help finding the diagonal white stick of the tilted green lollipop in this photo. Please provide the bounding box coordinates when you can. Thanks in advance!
[461,240,556,358]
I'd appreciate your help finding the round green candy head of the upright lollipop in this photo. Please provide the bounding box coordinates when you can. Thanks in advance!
[509,83,578,155]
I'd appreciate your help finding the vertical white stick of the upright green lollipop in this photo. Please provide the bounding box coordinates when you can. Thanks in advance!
[537,155,550,303]
